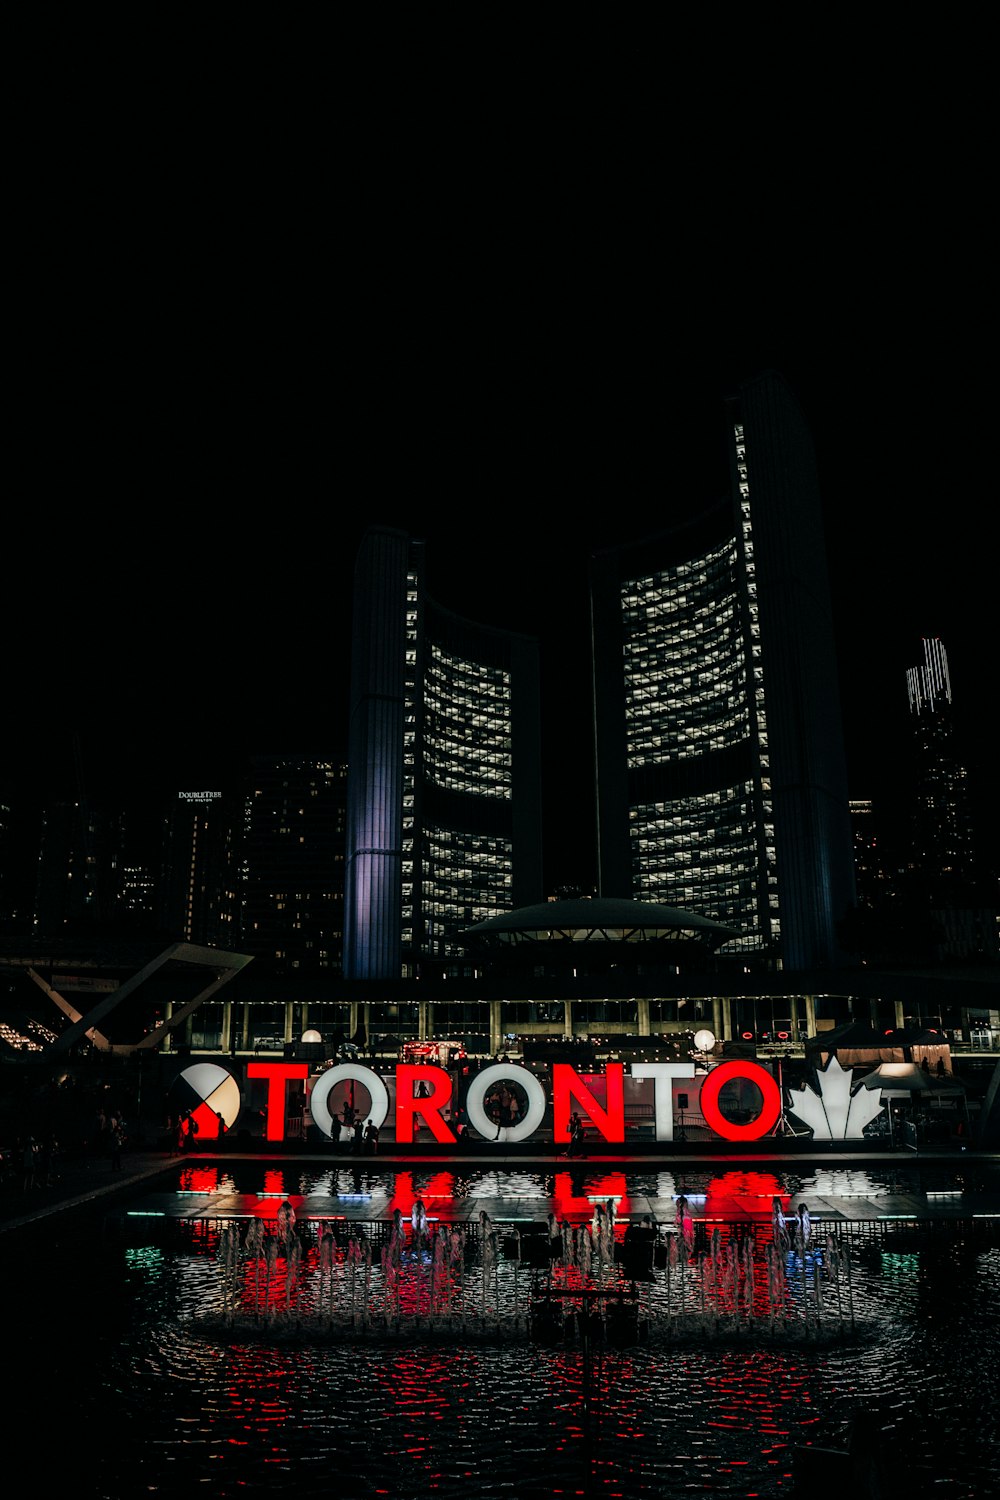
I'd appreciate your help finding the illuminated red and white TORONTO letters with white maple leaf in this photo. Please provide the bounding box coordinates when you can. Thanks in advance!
[230,1058,882,1145]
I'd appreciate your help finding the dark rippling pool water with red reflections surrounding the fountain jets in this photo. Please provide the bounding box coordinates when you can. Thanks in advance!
[11,1164,1000,1500]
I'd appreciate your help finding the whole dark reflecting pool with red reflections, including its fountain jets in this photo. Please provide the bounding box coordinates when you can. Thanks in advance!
[0,1163,1000,1500]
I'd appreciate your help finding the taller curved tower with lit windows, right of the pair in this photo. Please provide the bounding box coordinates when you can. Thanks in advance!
[591,372,855,969]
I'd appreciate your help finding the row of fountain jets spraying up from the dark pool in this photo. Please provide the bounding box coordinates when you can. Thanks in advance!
[208,1205,861,1347]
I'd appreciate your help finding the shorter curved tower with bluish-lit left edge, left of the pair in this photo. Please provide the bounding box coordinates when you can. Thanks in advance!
[345,527,541,980]
